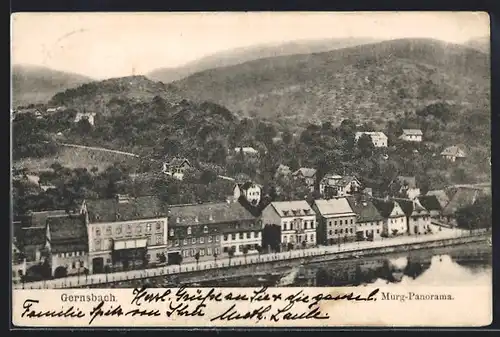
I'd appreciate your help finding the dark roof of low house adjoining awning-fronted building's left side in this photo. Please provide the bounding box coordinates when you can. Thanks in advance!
[47,216,88,253]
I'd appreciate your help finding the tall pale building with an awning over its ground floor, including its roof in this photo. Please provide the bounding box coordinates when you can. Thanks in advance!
[84,196,168,273]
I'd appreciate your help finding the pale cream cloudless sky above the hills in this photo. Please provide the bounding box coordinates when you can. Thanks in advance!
[11,12,490,79]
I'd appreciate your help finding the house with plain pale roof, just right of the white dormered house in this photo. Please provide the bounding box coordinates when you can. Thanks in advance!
[312,197,356,245]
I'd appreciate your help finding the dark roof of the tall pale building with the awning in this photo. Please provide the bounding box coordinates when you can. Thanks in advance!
[86,196,167,223]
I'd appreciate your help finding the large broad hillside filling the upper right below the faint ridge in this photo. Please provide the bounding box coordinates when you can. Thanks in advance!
[173,39,490,125]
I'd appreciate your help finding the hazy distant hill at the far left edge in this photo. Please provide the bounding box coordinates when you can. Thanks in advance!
[12,65,92,107]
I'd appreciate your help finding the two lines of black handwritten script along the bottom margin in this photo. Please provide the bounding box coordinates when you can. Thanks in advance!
[21,287,379,325]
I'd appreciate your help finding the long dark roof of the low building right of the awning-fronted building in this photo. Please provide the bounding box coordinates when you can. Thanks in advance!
[168,202,256,226]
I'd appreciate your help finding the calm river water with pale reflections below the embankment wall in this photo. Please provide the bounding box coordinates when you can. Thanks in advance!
[185,243,492,287]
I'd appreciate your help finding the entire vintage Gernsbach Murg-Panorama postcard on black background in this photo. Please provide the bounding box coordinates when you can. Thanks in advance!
[10,12,493,328]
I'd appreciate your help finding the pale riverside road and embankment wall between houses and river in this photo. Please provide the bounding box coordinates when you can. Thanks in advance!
[14,226,491,289]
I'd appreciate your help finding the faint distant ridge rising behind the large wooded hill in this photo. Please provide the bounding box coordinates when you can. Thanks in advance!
[146,38,374,83]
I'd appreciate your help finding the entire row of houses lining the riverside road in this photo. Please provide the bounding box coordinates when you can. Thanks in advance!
[13,181,464,277]
